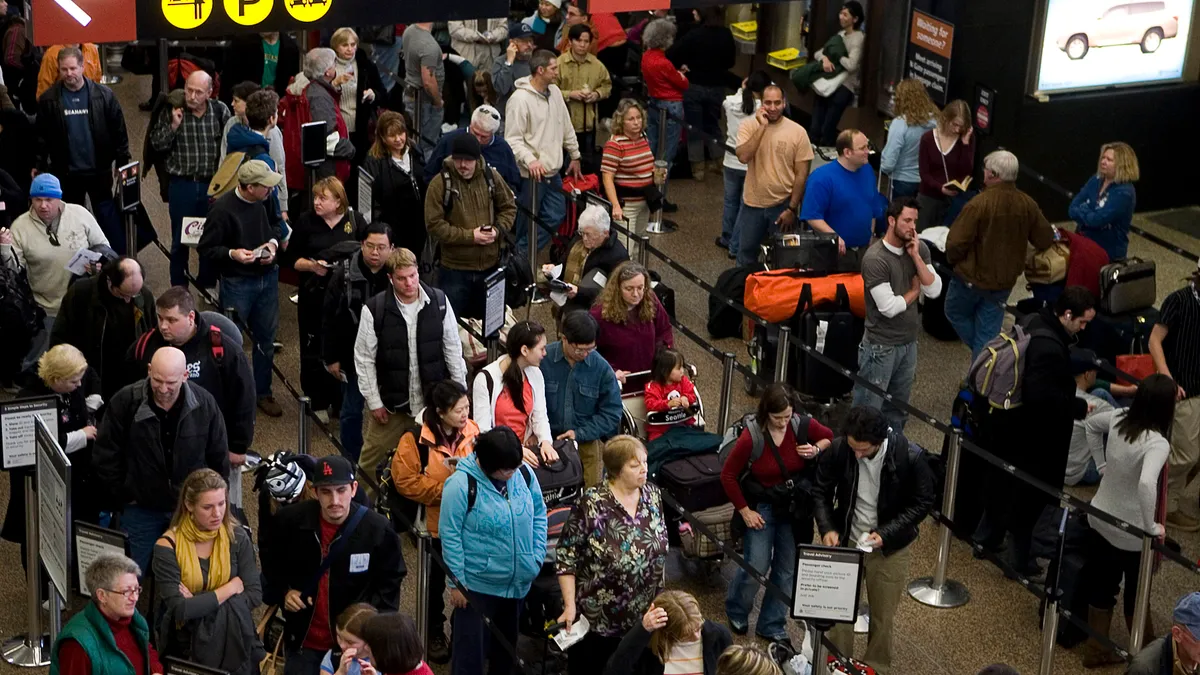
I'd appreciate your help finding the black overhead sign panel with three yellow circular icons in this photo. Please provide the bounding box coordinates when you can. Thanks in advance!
[138,0,509,40]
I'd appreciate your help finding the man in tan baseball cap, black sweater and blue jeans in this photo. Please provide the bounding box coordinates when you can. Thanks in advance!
[198,160,283,417]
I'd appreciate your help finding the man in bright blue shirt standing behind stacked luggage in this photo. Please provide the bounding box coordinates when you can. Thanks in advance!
[800,129,888,271]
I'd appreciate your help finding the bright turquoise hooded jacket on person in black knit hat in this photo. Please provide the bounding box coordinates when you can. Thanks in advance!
[438,454,546,598]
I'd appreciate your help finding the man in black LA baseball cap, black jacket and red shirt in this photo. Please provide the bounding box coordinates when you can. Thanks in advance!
[263,455,407,675]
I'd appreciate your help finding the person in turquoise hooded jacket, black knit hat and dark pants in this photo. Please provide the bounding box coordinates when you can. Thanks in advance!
[438,426,546,675]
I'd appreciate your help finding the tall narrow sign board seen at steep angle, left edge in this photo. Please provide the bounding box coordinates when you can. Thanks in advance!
[34,418,71,598]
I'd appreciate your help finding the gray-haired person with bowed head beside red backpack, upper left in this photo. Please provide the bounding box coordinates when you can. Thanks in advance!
[288,47,354,181]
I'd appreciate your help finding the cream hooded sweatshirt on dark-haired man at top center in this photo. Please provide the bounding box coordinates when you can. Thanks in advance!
[504,76,580,178]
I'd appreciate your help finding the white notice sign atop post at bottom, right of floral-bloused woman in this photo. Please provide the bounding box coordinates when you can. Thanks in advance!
[792,544,863,623]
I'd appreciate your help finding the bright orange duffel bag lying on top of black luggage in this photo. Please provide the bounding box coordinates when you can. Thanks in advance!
[743,269,866,323]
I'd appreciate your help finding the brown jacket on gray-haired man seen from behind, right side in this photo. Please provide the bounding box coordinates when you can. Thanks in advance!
[946,183,1054,291]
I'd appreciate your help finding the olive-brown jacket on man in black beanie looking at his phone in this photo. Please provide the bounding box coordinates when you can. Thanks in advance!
[425,157,517,271]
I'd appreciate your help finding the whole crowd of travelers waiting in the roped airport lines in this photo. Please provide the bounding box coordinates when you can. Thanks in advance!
[0,0,1200,675]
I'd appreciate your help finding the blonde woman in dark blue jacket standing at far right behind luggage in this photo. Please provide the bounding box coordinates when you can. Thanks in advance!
[1067,143,1139,261]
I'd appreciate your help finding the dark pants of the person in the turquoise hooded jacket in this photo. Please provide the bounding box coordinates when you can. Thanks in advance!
[450,591,522,675]
